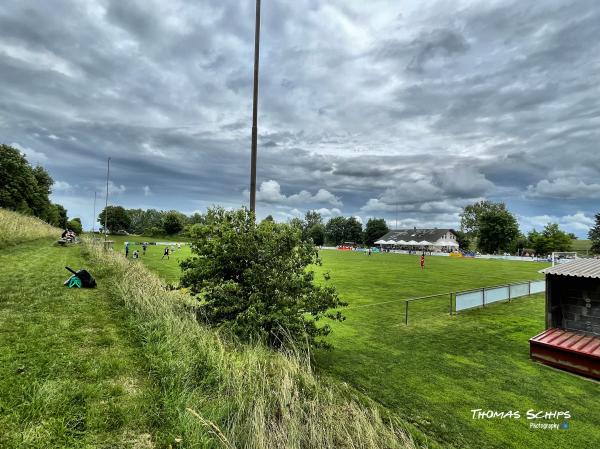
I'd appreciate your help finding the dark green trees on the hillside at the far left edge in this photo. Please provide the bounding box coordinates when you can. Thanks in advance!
[0,144,81,233]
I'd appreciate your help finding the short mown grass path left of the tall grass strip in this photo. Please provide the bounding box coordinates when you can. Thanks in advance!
[0,239,164,449]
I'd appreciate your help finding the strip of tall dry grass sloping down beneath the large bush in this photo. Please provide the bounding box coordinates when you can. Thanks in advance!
[83,241,424,449]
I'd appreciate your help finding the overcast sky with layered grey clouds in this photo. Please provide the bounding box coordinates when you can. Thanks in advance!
[0,0,600,237]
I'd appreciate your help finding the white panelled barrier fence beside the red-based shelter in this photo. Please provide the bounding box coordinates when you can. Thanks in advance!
[454,280,546,312]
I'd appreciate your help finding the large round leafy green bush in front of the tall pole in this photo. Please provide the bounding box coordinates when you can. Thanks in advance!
[181,208,346,348]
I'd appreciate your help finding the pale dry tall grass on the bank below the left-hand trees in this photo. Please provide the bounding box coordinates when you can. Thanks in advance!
[0,208,61,248]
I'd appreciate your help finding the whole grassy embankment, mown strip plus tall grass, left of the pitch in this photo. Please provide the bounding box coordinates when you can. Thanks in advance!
[0,214,426,449]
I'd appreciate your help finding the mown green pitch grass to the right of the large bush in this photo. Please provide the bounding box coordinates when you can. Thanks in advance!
[316,250,600,449]
